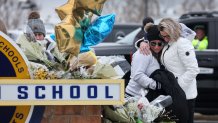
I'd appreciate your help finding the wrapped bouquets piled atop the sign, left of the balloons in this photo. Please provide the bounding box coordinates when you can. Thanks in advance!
[17,34,94,79]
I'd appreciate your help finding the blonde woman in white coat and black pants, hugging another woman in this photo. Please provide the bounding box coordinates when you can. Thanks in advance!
[158,18,199,123]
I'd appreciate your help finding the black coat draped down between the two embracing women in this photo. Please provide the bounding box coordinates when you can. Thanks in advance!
[150,69,189,123]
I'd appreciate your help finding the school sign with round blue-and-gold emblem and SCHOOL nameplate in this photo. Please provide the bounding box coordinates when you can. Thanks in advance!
[0,32,124,123]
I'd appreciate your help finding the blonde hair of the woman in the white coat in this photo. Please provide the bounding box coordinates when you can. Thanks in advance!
[158,18,181,41]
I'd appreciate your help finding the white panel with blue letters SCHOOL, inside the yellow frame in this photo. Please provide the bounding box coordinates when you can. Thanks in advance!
[0,83,121,101]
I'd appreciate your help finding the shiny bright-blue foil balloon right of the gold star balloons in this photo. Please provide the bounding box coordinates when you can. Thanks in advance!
[80,14,115,52]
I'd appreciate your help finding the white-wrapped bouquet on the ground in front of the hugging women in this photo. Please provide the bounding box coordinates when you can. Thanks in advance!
[120,89,177,123]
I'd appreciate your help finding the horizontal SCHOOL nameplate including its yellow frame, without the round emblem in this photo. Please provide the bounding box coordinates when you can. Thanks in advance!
[0,79,124,105]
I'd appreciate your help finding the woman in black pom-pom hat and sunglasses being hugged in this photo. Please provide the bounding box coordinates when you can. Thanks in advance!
[126,23,164,97]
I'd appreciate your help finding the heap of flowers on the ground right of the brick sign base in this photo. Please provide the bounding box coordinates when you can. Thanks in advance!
[103,94,177,123]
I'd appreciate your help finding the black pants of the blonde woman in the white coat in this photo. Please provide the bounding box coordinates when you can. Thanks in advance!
[187,99,195,123]
